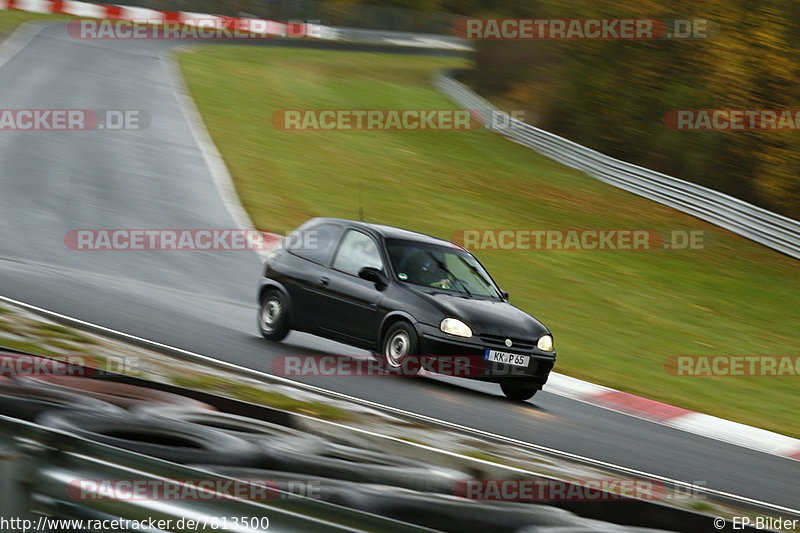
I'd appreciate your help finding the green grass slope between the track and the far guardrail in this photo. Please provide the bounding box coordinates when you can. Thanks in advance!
[180,46,800,436]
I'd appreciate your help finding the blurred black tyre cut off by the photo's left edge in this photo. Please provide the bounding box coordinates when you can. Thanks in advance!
[0,379,123,422]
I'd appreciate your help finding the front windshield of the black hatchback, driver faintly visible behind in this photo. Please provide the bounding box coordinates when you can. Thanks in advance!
[386,239,500,299]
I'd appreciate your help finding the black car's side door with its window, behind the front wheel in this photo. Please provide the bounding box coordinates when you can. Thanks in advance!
[320,229,386,344]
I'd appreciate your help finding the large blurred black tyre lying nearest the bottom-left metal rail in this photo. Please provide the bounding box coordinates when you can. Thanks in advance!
[36,411,263,466]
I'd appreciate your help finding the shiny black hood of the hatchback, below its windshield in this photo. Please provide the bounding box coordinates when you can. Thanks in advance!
[413,287,550,336]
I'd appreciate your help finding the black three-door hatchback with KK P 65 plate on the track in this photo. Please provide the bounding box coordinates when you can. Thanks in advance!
[258,218,556,400]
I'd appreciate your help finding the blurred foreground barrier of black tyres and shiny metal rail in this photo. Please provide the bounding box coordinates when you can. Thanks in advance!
[0,352,768,533]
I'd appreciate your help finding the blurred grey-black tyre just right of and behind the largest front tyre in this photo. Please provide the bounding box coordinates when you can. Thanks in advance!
[135,404,329,453]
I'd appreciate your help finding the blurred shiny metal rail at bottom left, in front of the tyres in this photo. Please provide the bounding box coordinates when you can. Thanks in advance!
[0,416,429,533]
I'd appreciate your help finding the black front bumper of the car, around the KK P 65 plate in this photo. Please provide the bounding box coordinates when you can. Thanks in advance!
[415,323,556,385]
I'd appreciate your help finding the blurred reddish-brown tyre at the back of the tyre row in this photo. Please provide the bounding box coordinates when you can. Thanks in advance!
[16,375,215,411]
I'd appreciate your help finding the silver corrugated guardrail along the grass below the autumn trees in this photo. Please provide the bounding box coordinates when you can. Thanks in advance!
[433,71,800,259]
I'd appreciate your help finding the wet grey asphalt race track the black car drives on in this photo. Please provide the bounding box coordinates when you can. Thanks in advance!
[0,25,800,508]
